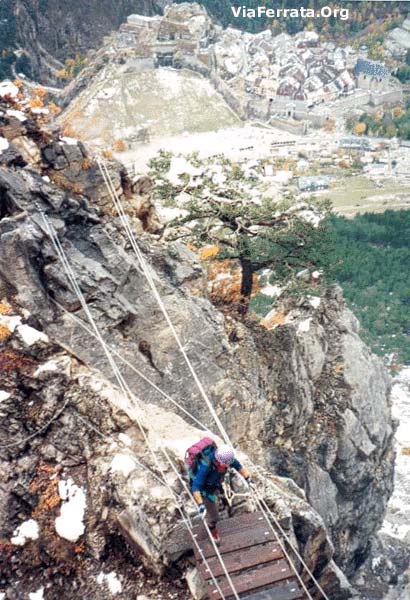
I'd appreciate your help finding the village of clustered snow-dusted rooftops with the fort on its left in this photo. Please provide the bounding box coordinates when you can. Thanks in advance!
[111,4,403,126]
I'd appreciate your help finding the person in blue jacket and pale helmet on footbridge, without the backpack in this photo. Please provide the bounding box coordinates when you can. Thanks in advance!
[191,446,254,544]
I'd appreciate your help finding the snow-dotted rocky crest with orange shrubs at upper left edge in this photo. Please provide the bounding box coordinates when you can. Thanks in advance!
[0,91,148,216]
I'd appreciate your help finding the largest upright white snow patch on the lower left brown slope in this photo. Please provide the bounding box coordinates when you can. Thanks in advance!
[55,479,86,542]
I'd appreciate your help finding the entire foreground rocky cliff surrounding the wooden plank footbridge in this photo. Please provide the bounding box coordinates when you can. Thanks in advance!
[0,88,394,600]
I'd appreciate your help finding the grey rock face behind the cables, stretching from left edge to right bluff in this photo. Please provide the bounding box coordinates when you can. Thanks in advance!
[0,110,394,600]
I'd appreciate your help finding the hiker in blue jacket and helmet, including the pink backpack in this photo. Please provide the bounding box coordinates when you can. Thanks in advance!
[185,438,253,544]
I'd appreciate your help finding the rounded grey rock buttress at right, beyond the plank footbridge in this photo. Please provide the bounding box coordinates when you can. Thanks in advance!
[258,288,394,573]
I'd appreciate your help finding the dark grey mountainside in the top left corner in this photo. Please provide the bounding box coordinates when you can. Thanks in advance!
[12,0,165,83]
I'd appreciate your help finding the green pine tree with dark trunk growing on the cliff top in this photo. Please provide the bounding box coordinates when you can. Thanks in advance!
[167,197,326,312]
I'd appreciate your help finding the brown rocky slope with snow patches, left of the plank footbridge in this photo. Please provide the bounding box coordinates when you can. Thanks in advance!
[0,316,189,599]
